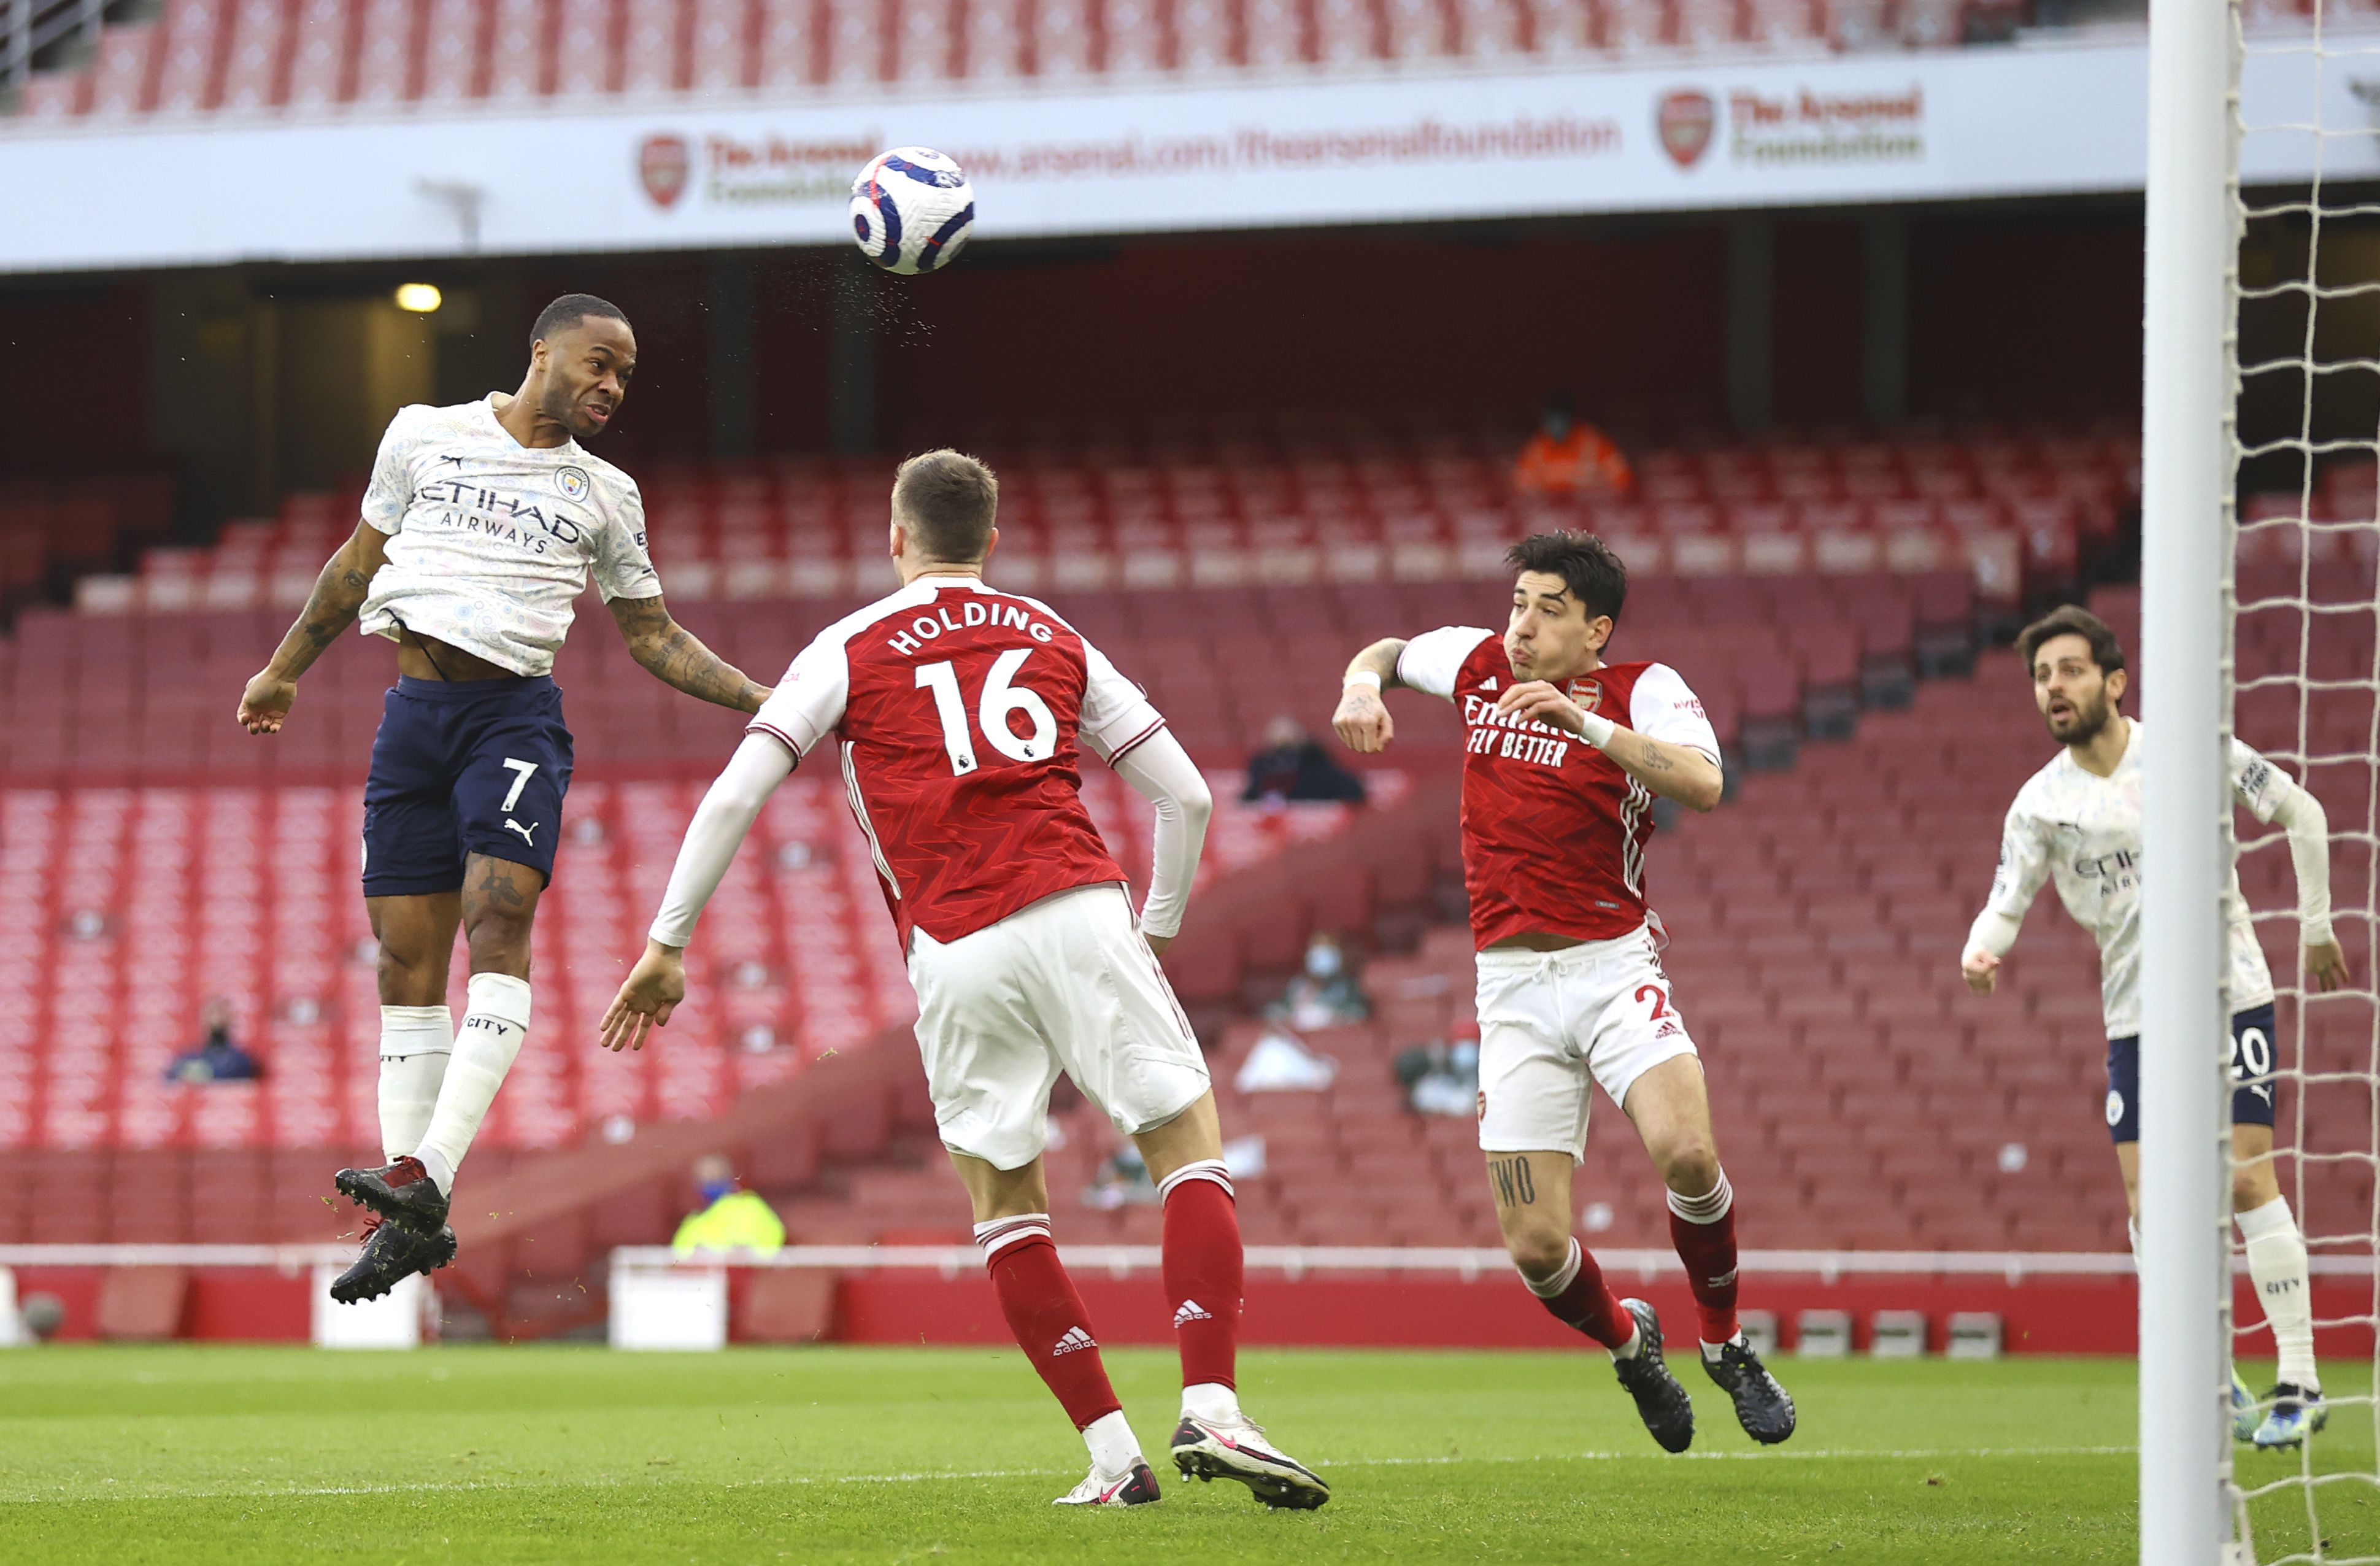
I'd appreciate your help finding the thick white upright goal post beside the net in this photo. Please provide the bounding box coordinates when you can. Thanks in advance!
[2139,0,2237,1566]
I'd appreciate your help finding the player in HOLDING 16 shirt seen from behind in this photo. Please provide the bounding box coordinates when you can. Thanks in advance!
[604,452,1330,1509]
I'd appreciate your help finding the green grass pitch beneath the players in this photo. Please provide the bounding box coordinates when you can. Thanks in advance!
[0,1347,2380,1566]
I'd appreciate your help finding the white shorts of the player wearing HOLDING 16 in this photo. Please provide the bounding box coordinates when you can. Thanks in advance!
[909,885,1209,1168]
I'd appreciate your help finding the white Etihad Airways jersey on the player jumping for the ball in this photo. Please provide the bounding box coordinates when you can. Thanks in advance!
[347,400,661,674]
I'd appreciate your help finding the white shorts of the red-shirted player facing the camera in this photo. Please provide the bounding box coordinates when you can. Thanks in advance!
[1478,928,1695,1159]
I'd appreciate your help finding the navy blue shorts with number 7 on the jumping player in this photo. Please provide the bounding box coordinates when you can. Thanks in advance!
[364,676,571,897]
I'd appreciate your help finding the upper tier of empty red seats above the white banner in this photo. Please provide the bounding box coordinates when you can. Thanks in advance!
[0,0,2046,119]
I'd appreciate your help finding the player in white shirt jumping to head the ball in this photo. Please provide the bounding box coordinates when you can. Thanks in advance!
[238,293,769,1302]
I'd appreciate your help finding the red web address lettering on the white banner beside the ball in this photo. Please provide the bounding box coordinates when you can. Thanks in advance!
[952,114,1621,183]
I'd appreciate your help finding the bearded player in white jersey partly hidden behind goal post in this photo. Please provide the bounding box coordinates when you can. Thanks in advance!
[1958,604,2347,1447]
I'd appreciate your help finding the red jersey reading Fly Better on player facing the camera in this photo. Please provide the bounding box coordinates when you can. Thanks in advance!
[1397,626,1719,949]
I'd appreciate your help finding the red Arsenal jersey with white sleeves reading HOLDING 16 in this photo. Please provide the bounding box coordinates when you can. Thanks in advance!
[733,576,1164,947]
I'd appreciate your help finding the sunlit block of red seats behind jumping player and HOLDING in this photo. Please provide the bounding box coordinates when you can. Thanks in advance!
[0,757,1402,1152]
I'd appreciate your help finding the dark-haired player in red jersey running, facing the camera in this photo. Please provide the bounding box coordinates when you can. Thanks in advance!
[1333,533,1795,1452]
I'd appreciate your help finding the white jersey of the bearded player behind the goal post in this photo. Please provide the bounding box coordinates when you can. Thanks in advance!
[1985,719,2297,1038]
